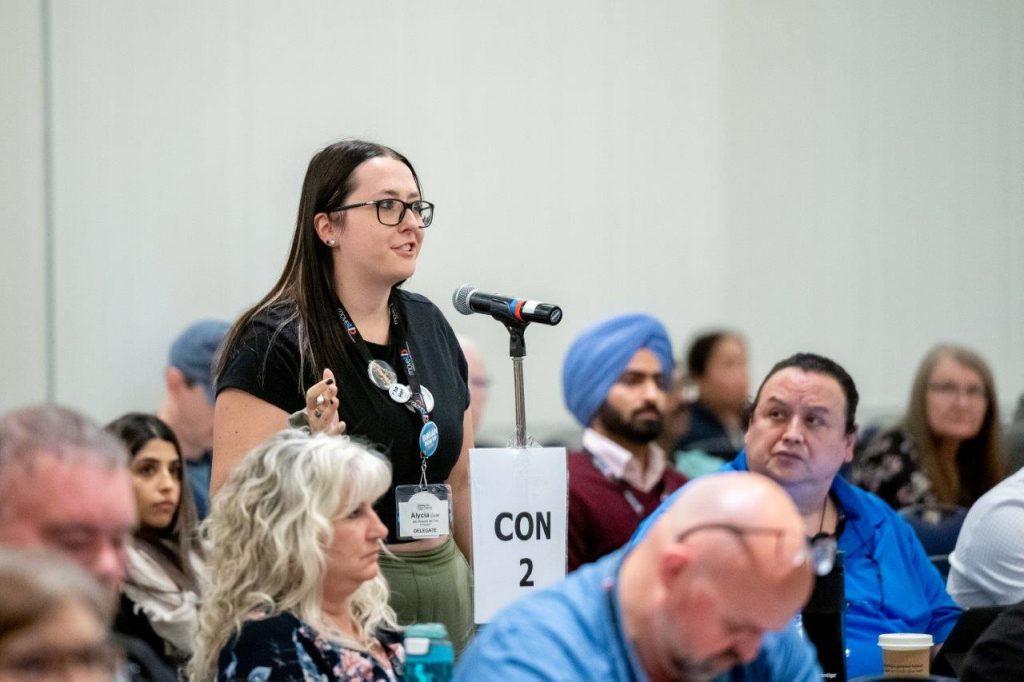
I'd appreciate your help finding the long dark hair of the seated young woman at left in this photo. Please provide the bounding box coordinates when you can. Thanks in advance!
[106,412,203,591]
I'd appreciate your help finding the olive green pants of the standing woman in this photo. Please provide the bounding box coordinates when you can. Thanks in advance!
[380,537,474,655]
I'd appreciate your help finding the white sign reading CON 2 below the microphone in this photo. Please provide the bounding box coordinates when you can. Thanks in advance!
[469,447,568,623]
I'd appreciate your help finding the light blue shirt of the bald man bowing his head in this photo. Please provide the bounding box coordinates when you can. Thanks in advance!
[455,549,821,682]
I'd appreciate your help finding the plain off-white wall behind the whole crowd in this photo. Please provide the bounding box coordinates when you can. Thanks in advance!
[0,0,1024,444]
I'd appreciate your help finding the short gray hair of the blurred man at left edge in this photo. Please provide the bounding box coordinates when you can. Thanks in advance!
[0,404,128,478]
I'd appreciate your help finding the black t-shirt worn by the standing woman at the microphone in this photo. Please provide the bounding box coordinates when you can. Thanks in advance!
[217,289,469,543]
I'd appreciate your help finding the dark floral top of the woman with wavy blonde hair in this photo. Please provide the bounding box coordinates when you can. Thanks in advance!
[217,613,406,682]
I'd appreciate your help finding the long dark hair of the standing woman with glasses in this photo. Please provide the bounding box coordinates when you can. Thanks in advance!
[217,139,422,390]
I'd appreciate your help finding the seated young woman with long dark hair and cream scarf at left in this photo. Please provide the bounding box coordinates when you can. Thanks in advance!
[106,413,203,668]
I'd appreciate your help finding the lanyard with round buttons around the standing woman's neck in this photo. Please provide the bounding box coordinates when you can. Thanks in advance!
[338,294,439,477]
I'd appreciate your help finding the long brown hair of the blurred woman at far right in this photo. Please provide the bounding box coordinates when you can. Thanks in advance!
[903,343,1005,506]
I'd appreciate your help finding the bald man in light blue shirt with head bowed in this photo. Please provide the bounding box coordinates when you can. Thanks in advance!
[456,473,821,682]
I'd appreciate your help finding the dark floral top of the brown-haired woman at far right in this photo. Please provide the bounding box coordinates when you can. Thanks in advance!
[850,428,936,509]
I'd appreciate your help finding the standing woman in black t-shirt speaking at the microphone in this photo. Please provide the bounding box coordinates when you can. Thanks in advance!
[211,140,473,648]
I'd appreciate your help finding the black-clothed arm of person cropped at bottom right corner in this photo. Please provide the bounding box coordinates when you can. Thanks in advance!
[959,603,1024,682]
